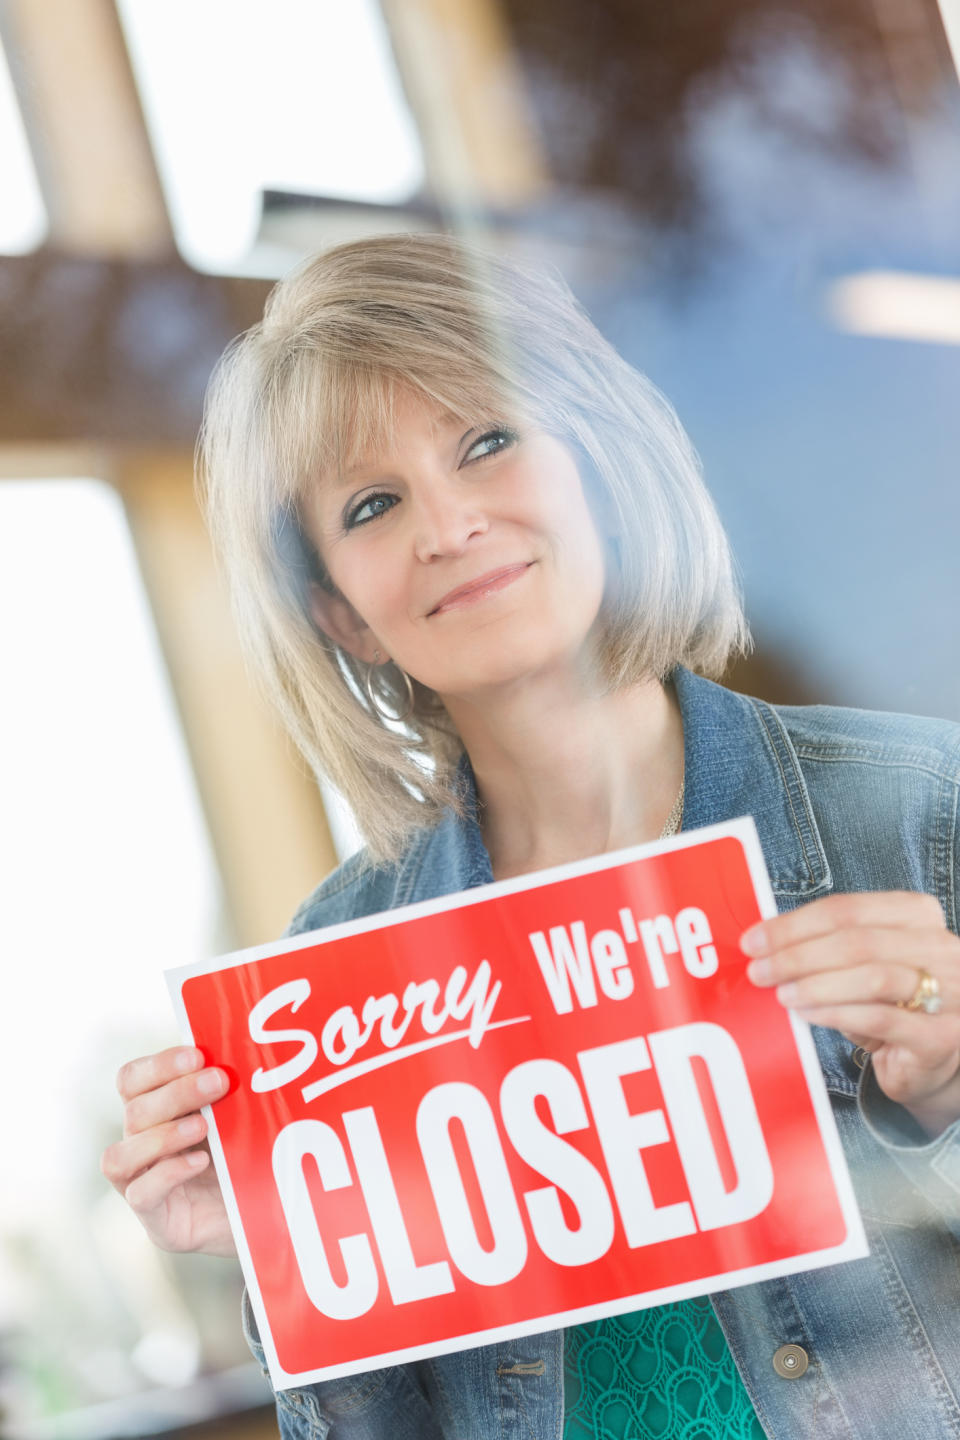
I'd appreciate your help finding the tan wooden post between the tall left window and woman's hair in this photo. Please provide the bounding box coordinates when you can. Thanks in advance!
[111,452,337,945]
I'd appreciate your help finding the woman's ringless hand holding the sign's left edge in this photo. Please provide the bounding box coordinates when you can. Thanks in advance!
[101,1047,236,1256]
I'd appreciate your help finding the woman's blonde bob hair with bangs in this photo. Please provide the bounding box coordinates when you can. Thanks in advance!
[199,235,747,863]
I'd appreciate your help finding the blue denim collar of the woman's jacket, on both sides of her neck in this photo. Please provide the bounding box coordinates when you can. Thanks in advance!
[393,668,833,907]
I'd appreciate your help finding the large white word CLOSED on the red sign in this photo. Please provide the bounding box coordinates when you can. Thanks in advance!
[272,1019,774,1319]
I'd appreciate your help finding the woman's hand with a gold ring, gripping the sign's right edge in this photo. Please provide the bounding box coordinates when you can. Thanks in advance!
[740,891,960,1136]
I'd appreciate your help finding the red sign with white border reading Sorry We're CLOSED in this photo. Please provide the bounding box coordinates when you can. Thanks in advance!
[170,819,866,1388]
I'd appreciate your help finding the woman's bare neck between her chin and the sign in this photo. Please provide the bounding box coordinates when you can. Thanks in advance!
[448,681,684,880]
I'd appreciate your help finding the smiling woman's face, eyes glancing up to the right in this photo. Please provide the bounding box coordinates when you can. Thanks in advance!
[302,396,604,698]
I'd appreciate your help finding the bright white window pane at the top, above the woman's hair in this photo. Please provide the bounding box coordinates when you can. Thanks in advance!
[118,0,423,274]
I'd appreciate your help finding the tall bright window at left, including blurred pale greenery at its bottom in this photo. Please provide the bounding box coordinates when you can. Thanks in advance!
[0,480,230,1416]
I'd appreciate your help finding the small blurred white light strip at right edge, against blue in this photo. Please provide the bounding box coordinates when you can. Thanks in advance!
[828,271,960,346]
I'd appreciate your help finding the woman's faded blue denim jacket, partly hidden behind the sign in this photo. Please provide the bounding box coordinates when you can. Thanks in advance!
[245,670,960,1440]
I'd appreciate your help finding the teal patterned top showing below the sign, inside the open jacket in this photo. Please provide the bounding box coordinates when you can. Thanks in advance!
[563,1295,764,1440]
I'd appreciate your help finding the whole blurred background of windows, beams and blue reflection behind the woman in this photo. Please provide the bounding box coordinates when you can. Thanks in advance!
[0,0,960,1440]
